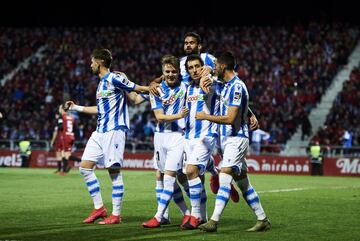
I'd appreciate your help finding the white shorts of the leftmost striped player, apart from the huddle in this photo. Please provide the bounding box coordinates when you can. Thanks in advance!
[81,130,125,168]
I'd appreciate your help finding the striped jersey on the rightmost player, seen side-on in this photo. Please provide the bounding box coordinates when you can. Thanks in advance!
[219,76,249,138]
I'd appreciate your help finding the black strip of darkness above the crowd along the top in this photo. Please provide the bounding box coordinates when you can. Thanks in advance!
[0,0,360,27]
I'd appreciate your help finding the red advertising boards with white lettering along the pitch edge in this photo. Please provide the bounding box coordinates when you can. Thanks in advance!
[0,150,360,177]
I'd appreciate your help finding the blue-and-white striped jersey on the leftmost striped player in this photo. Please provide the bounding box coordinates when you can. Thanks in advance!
[96,72,136,133]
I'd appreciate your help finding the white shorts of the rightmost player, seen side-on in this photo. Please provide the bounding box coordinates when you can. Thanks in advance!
[220,136,249,174]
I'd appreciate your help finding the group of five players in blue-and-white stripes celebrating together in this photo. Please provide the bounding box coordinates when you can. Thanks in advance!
[65,32,270,232]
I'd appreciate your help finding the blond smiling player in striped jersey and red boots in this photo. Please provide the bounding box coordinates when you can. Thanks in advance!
[143,55,190,228]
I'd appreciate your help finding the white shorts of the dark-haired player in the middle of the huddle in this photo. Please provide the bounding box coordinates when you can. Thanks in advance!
[183,136,216,175]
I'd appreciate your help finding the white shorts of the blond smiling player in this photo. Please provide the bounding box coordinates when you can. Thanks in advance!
[154,132,185,173]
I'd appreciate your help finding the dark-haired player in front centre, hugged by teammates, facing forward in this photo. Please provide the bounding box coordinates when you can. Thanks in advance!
[183,55,219,229]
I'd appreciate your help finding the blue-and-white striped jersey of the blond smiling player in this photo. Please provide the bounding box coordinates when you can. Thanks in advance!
[150,81,187,132]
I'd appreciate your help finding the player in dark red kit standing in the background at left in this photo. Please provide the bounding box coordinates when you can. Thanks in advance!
[50,105,75,176]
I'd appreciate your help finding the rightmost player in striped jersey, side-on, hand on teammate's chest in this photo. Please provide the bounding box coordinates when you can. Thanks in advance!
[196,52,270,232]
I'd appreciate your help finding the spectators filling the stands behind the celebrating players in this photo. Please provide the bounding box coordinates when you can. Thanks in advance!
[0,23,359,151]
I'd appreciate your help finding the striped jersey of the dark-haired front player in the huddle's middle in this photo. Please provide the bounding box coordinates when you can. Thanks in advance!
[185,81,222,139]
